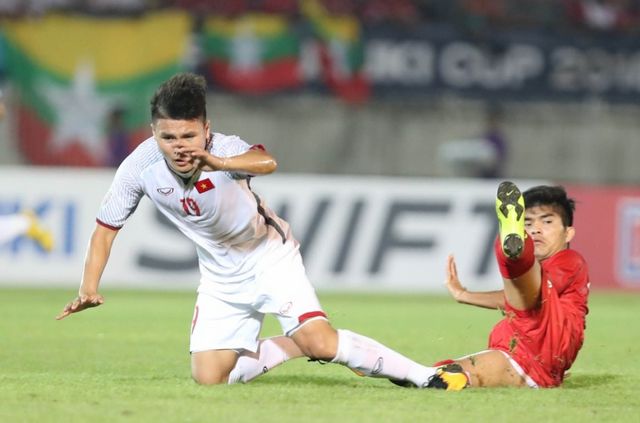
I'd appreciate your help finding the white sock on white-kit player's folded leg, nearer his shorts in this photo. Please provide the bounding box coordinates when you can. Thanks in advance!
[229,336,302,385]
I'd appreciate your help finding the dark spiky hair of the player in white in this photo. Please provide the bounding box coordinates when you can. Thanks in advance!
[151,73,207,122]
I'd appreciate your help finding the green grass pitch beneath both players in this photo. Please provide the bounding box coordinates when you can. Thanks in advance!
[0,288,640,423]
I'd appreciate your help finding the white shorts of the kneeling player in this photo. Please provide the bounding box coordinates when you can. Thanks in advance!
[189,252,326,353]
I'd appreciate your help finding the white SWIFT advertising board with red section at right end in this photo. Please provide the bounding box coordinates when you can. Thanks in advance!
[0,167,640,292]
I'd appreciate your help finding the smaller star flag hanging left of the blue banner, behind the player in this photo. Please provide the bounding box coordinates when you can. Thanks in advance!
[203,14,302,94]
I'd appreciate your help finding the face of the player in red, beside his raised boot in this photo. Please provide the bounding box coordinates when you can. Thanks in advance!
[524,206,575,260]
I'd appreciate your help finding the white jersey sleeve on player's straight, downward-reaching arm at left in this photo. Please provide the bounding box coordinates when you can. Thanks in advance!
[96,156,144,230]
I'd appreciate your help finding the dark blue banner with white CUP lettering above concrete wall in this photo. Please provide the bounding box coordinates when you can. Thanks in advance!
[205,22,640,102]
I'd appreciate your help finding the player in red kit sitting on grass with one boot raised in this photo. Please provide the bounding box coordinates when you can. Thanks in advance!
[439,182,589,388]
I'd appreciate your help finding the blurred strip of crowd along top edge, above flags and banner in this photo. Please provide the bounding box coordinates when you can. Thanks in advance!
[0,0,640,34]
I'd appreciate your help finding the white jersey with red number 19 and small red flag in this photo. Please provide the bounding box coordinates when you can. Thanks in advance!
[97,133,298,294]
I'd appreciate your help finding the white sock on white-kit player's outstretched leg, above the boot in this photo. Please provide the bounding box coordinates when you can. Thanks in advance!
[331,329,436,387]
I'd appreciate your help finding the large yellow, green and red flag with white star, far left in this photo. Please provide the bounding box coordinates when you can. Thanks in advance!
[2,12,191,166]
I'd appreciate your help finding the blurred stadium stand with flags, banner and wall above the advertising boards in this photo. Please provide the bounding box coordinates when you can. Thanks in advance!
[0,0,640,183]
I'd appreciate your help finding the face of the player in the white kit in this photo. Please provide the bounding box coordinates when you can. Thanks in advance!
[151,119,209,173]
